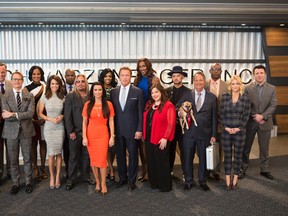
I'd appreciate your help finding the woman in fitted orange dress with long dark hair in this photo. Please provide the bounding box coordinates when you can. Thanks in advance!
[82,82,115,195]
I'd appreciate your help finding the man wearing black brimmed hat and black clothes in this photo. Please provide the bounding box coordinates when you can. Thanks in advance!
[166,66,191,177]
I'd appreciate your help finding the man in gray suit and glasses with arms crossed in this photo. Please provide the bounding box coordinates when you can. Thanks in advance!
[2,72,35,195]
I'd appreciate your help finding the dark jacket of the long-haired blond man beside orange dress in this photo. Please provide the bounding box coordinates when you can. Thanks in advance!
[64,92,84,136]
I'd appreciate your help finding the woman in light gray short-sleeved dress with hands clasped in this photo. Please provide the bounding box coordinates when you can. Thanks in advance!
[38,75,65,189]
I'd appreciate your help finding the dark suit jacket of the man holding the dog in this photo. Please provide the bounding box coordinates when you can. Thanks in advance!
[176,90,218,140]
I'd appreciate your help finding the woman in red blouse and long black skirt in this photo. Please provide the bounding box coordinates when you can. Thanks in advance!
[143,84,176,192]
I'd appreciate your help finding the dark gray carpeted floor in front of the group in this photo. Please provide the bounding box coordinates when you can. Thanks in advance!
[0,156,288,216]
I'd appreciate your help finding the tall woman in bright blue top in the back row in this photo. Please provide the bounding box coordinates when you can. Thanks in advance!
[134,58,160,181]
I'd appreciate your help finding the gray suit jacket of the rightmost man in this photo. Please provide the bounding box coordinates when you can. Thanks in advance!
[245,82,277,130]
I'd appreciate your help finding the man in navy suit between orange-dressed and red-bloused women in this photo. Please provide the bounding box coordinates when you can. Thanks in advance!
[110,67,144,190]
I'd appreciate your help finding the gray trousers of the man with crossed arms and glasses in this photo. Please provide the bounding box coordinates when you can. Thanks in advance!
[7,130,32,185]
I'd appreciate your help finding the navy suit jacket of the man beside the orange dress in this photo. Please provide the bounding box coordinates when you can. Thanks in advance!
[110,85,144,138]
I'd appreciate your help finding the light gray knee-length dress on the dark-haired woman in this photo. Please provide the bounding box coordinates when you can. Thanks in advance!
[40,93,65,156]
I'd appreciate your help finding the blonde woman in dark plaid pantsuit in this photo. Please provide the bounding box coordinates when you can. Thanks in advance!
[221,75,250,190]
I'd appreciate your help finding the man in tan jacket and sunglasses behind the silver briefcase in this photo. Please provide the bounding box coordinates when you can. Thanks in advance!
[205,63,228,181]
